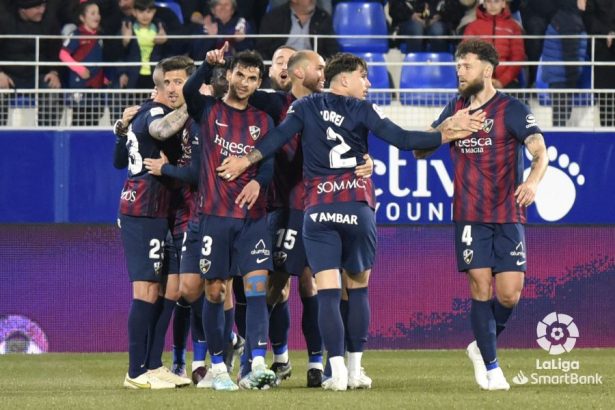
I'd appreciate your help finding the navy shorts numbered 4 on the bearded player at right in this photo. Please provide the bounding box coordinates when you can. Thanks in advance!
[455,222,527,273]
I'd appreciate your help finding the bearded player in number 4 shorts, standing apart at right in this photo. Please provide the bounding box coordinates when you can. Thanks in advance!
[415,40,548,390]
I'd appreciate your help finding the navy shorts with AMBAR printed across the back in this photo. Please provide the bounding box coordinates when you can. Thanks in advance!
[303,202,377,274]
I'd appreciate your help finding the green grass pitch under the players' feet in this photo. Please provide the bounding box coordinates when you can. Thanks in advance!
[0,349,615,410]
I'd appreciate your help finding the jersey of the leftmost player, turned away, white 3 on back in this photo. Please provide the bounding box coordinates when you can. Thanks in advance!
[119,101,179,218]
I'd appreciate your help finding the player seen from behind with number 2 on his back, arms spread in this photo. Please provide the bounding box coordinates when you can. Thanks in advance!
[217,53,482,391]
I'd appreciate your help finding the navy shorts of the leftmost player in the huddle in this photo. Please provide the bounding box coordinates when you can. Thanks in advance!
[119,215,169,282]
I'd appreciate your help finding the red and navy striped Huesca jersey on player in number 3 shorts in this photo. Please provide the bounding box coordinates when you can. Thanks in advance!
[191,96,273,219]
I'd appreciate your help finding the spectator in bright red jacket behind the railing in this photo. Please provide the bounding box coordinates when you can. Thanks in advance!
[463,0,525,88]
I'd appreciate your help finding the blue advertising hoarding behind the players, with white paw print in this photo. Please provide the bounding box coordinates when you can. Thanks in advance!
[0,131,615,225]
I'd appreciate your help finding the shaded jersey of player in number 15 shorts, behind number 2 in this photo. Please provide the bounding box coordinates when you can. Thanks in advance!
[250,91,305,211]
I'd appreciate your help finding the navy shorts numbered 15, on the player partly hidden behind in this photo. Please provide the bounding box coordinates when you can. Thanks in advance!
[267,208,307,276]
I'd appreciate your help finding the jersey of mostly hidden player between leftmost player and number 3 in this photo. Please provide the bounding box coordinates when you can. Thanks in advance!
[172,118,199,236]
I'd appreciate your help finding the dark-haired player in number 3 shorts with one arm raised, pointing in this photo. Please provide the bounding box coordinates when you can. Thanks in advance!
[156,44,275,390]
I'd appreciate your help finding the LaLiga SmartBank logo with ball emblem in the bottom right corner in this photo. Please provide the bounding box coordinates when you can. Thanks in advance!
[513,312,602,385]
